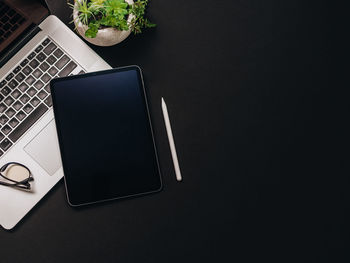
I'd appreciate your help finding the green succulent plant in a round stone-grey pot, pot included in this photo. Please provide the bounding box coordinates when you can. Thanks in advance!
[70,0,155,46]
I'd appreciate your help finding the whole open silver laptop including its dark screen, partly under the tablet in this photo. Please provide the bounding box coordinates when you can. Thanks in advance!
[0,0,111,229]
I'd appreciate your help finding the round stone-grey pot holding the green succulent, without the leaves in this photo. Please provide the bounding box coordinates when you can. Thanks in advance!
[73,0,135,47]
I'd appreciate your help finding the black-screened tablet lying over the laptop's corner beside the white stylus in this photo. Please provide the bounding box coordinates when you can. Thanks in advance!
[50,66,162,206]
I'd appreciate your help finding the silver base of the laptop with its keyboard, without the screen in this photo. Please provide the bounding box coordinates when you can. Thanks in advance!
[0,16,111,229]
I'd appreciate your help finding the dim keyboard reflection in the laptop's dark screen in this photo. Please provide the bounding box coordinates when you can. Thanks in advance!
[0,1,25,44]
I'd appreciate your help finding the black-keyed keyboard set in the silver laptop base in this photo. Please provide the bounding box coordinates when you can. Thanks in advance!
[0,38,85,156]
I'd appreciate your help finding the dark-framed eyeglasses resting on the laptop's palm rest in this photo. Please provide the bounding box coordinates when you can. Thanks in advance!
[0,162,34,190]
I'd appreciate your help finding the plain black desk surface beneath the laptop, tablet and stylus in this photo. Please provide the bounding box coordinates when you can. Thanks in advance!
[0,0,350,263]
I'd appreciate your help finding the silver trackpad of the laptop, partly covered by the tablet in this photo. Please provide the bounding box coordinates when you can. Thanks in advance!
[24,120,62,175]
